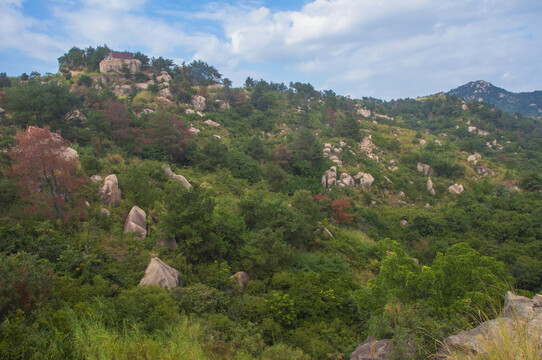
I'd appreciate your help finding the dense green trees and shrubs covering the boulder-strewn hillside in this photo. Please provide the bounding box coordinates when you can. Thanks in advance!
[0,46,542,359]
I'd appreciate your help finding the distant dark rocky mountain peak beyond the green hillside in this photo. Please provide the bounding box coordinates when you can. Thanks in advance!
[447,80,542,116]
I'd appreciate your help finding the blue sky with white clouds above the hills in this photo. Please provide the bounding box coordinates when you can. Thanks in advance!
[0,0,542,100]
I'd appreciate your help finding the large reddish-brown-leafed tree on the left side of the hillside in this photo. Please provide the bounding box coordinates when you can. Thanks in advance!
[8,126,86,220]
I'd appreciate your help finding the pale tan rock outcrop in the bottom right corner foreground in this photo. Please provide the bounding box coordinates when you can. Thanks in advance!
[437,292,542,358]
